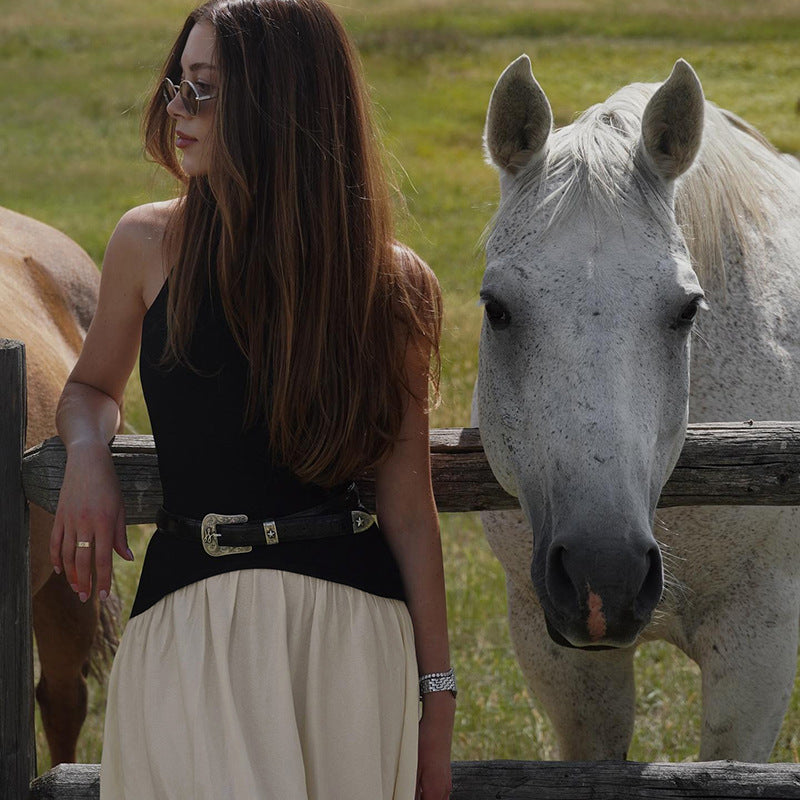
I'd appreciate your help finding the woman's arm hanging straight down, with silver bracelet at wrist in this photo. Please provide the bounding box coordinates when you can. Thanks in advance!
[375,344,455,800]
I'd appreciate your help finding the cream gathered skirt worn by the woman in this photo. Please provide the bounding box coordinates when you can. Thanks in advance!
[100,569,419,800]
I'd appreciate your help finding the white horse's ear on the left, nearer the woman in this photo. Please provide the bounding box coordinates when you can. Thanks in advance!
[483,55,553,175]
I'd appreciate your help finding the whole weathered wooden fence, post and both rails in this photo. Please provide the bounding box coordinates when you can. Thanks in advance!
[0,340,800,800]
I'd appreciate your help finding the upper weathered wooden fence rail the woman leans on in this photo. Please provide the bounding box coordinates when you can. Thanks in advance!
[22,421,800,523]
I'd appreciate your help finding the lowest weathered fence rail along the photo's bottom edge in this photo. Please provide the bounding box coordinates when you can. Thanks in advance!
[30,761,800,800]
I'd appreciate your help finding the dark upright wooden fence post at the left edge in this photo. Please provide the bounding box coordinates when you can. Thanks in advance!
[0,339,36,800]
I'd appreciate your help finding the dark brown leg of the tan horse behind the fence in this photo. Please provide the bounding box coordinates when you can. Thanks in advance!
[33,573,99,766]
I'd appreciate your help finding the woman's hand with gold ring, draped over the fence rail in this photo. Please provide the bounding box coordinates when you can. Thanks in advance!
[50,441,133,603]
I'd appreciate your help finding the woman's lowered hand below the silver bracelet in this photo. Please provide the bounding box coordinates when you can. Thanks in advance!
[416,692,456,800]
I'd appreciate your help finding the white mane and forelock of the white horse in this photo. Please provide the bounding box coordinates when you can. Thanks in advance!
[493,84,788,285]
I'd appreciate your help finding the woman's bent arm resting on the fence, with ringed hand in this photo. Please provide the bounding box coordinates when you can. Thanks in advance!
[50,207,161,601]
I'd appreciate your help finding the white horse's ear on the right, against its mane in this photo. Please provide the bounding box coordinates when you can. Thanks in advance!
[642,58,705,180]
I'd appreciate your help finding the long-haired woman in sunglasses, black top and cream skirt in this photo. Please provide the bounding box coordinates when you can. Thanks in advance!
[51,0,455,800]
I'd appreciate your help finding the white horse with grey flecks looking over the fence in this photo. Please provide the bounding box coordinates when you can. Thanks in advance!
[473,56,800,761]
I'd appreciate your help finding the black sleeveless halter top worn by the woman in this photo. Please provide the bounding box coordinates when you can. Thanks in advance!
[131,272,404,617]
